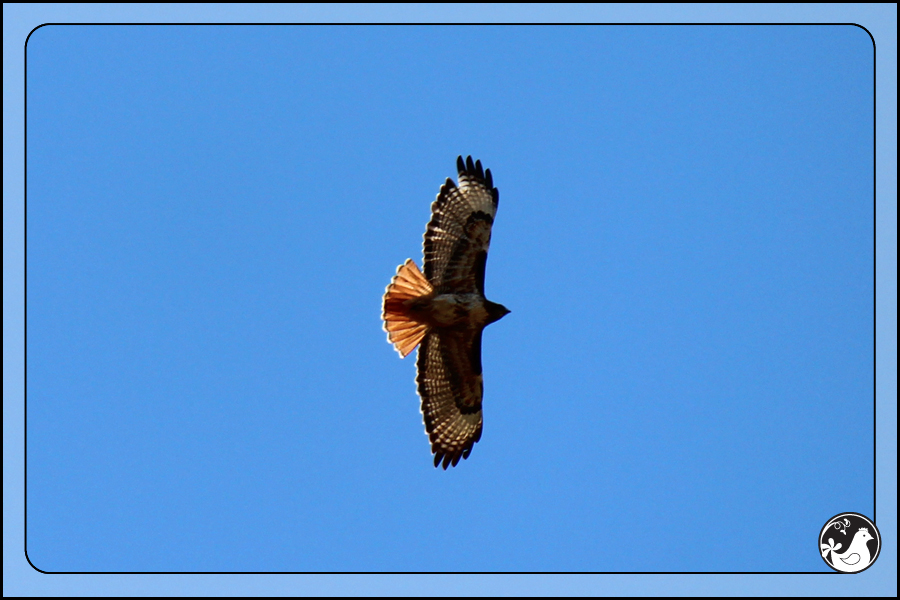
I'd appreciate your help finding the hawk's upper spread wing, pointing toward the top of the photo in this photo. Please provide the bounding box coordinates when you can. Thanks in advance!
[423,156,500,295]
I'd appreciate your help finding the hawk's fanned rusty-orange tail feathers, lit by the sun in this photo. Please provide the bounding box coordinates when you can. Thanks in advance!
[381,258,434,358]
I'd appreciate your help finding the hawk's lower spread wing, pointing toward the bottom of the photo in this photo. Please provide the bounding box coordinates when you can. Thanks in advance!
[416,329,484,469]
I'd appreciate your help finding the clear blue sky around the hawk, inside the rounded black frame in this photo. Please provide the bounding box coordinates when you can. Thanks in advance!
[4,2,896,593]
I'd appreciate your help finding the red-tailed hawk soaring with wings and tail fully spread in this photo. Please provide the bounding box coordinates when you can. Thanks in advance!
[381,156,509,469]
